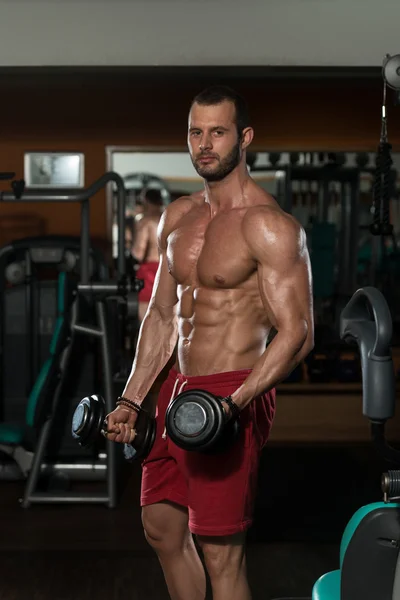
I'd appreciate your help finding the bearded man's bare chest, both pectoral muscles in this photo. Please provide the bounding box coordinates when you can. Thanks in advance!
[167,214,255,289]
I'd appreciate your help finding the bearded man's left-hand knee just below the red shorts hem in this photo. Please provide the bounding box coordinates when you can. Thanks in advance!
[142,502,191,553]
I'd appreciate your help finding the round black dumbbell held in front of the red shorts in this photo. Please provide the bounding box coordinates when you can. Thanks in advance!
[165,389,240,454]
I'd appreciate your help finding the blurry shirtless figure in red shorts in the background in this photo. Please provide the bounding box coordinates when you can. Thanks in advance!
[132,189,164,322]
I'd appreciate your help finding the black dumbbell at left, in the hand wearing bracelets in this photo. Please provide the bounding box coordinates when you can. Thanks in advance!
[72,394,156,461]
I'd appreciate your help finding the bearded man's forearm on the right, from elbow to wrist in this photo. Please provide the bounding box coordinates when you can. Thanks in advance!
[232,332,313,409]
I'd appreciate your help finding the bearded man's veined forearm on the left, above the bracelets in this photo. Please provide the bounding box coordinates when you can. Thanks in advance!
[123,306,178,404]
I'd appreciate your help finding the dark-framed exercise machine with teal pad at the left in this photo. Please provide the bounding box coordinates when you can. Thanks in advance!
[0,172,143,508]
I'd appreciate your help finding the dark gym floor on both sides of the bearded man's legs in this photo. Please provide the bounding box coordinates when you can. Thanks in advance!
[0,447,387,600]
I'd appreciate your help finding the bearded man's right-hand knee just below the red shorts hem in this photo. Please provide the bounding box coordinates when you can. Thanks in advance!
[197,533,246,579]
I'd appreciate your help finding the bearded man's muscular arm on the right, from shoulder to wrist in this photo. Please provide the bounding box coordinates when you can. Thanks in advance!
[232,207,314,409]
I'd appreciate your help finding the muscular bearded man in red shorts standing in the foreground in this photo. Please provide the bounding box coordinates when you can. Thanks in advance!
[108,87,314,600]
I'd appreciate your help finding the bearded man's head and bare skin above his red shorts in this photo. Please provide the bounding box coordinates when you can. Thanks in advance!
[108,102,314,443]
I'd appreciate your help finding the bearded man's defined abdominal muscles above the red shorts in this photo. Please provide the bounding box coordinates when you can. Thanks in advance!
[175,287,271,377]
